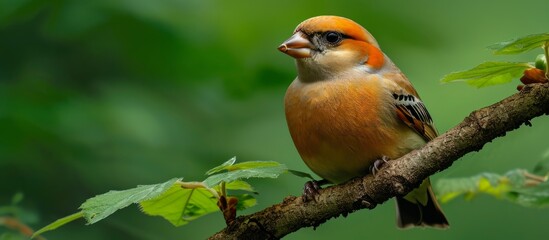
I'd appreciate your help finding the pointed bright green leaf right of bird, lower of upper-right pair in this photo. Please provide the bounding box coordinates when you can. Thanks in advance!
[440,62,532,88]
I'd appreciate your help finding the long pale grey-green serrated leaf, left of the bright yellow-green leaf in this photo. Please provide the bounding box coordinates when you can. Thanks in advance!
[80,178,179,224]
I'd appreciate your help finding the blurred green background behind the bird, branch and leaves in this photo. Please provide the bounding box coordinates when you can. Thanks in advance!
[0,0,549,240]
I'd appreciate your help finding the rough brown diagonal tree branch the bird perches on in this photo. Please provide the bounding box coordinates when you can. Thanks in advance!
[210,83,549,239]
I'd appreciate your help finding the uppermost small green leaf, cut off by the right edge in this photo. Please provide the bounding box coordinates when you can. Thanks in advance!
[488,33,549,54]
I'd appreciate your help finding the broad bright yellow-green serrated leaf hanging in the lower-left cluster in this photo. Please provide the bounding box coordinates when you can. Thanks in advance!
[139,184,219,227]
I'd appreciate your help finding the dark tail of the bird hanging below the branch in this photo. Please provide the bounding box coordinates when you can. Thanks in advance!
[396,178,449,228]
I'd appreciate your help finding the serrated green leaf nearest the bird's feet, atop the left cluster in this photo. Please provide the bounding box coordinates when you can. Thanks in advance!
[203,162,288,187]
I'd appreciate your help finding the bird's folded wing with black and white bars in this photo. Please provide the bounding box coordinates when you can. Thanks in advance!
[392,74,438,141]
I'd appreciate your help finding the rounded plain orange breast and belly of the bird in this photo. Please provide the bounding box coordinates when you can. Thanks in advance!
[285,76,418,183]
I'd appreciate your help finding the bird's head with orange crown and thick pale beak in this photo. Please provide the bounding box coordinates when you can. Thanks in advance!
[278,16,386,82]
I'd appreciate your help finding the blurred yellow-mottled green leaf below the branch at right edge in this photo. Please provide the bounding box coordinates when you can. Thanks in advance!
[435,169,549,207]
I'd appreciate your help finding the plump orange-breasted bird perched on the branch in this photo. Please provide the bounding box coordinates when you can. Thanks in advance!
[278,16,449,228]
